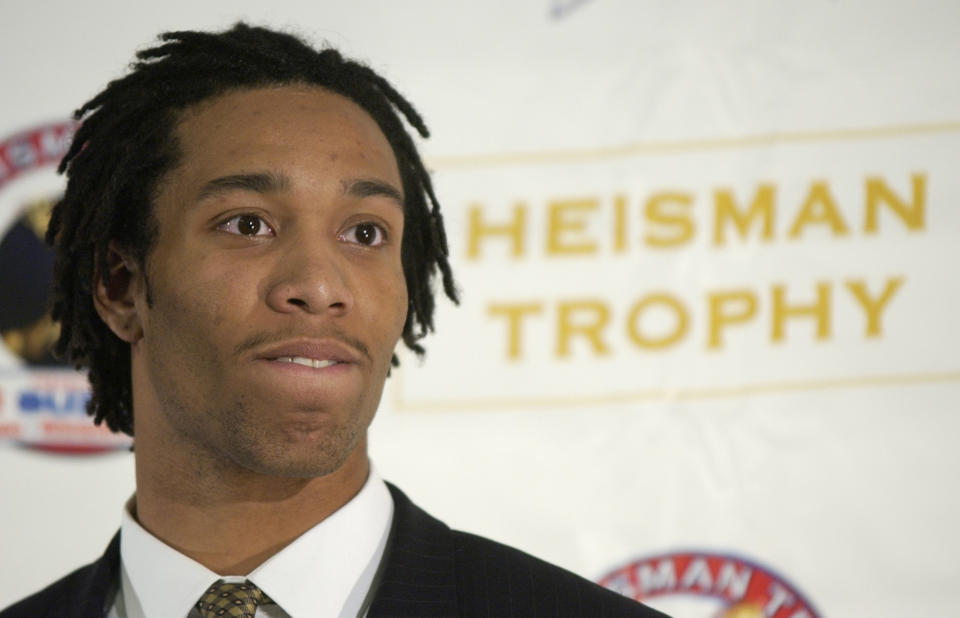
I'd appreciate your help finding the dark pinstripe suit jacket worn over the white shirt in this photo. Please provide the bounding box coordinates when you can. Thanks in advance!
[0,484,665,618]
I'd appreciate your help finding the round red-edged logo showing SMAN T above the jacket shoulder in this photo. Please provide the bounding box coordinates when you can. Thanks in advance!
[599,552,821,618]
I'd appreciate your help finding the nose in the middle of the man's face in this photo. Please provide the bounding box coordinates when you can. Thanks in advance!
[267,237,353,316]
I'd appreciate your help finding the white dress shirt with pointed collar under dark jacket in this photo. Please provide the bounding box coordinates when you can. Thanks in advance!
[107,466,393,618]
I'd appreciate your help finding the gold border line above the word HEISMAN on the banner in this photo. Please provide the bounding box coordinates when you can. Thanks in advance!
[427,121,960,170]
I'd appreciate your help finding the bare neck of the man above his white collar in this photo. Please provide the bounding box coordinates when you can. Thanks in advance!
[134,439,369,575]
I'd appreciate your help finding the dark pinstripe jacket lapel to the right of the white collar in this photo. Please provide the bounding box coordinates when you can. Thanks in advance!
[367,483,459,618]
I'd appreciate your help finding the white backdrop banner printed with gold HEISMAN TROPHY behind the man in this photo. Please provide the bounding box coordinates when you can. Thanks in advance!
[0,0,960,618]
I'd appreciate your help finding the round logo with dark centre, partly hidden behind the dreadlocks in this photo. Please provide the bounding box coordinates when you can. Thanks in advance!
[0,122,130,454]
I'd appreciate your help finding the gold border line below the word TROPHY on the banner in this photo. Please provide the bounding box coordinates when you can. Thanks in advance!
[393,371,960,412]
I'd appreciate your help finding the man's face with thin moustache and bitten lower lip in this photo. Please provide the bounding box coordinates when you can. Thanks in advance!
[132,86,407,477]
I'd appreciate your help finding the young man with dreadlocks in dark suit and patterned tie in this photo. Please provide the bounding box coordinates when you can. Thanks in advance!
[0,24,659,618]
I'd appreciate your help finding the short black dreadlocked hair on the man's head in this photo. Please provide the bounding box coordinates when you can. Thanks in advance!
[46,23,458,435]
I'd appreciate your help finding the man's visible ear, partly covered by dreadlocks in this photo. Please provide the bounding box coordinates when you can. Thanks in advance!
[93,242,145,343]
